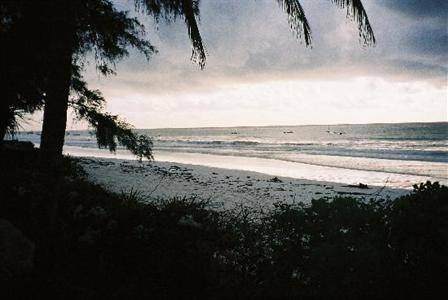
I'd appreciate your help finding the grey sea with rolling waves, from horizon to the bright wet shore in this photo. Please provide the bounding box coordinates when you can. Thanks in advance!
[12,122,448,188]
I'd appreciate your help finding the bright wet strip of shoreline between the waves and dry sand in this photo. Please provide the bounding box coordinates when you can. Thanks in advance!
[64,146,438,190]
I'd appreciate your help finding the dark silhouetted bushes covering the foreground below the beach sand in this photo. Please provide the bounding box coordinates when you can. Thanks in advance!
[0,144,448,299]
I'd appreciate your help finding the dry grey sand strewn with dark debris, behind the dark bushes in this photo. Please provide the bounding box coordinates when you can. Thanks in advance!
[77,157,409,210]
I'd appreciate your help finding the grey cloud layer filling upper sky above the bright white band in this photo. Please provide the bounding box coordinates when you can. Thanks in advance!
[86,0,448,93]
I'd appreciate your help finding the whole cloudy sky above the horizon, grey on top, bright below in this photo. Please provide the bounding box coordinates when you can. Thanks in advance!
[28,0,448,129]
